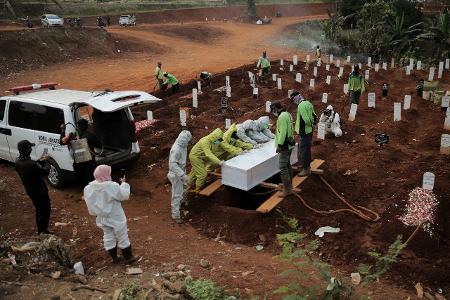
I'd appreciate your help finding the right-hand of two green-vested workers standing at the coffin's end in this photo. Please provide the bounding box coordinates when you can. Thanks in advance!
[295,96,317,176]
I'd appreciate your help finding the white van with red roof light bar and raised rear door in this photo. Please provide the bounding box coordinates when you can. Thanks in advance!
[0,83,161,188]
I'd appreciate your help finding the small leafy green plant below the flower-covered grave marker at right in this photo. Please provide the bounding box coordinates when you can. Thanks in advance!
[358,235,406,285]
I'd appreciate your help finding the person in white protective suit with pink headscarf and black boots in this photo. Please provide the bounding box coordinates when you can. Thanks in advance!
[84,165,139,264]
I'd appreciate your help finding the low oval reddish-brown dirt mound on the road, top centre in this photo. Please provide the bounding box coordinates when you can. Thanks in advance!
[151,24,226,43]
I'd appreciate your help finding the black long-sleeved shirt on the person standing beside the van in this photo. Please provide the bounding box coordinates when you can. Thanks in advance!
[15,159,50,198]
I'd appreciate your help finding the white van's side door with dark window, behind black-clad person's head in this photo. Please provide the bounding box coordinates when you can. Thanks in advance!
[6,100,39,161]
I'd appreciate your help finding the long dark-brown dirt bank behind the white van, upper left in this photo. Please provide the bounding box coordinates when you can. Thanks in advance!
[0,28,163,76]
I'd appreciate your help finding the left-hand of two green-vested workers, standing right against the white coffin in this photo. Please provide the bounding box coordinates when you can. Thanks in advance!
[270,102,295,197]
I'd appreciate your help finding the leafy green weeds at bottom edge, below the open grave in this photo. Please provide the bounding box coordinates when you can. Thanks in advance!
[274,211,353,300]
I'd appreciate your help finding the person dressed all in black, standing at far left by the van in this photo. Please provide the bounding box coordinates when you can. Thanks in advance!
[15,140,51,234]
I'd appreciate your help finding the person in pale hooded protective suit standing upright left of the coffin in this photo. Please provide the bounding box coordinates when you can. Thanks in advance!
[167,130,192,224]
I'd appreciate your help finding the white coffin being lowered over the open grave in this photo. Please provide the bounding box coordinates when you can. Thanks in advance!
[222,140,297,191]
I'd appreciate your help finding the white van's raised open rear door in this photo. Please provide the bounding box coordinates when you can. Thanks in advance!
[85,91,161,112]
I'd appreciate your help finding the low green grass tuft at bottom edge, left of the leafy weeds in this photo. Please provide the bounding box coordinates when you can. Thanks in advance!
[186,279,236,300]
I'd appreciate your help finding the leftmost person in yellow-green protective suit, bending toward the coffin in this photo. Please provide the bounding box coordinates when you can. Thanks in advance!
[188,128,223,189]
